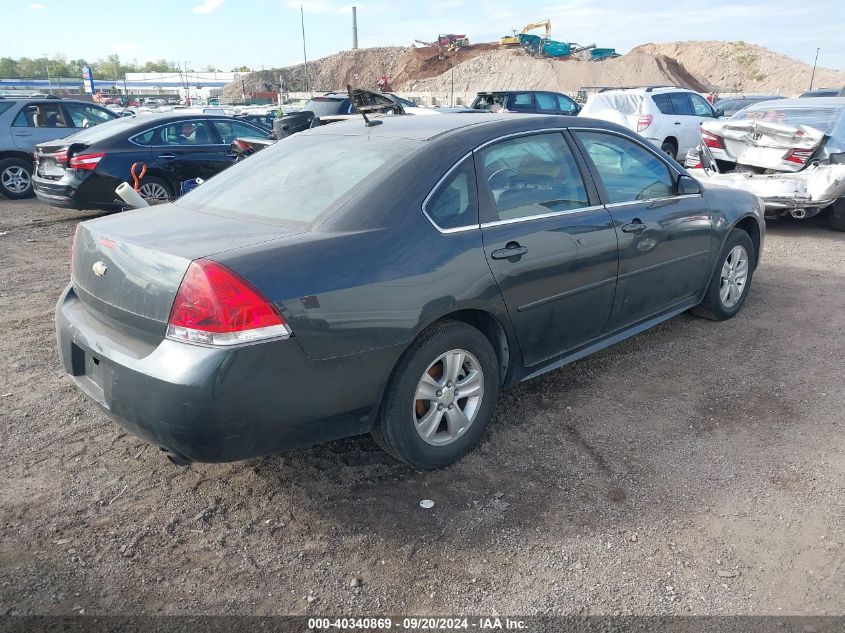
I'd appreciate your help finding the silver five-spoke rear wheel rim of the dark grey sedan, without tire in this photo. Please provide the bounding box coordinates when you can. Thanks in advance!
[413,349,484,446]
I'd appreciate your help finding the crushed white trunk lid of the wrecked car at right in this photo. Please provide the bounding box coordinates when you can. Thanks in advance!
[702,119,826,172]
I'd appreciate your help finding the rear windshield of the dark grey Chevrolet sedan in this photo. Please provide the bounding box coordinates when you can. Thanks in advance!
[176,131,420,225]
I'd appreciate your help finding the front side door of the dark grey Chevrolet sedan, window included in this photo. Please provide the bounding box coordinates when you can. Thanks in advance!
[573,129,712,331]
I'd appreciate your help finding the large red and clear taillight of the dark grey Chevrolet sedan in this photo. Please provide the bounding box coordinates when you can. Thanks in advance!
[167,259,291,345]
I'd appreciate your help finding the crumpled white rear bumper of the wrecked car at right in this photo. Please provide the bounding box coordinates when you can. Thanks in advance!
[689,165,845,218]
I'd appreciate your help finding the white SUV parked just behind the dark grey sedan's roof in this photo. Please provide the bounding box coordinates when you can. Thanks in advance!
[578,87,717,158]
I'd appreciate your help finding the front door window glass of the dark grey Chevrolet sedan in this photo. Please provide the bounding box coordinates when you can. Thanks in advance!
[575,131,674,203]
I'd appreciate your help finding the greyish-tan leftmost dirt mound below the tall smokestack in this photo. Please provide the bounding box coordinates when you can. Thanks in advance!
[223,46,414,99]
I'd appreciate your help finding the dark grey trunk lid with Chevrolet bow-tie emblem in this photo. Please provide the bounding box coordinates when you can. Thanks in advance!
[71,205,305,342]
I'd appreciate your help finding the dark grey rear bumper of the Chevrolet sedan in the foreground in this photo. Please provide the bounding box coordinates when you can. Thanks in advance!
[56,286,401,462]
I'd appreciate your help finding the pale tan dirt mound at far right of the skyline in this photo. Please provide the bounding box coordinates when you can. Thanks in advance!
[626,41,845,96]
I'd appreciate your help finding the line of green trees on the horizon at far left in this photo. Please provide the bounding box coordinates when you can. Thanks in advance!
[0,54,250,80]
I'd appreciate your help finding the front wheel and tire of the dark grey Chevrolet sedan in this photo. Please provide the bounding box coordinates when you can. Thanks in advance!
[690,229,757,321]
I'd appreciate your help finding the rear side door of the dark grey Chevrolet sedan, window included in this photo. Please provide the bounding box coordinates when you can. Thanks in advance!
[475,131,617,366]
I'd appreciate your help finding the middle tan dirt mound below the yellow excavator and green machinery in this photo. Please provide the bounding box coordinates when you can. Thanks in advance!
[402,49,710,92]
